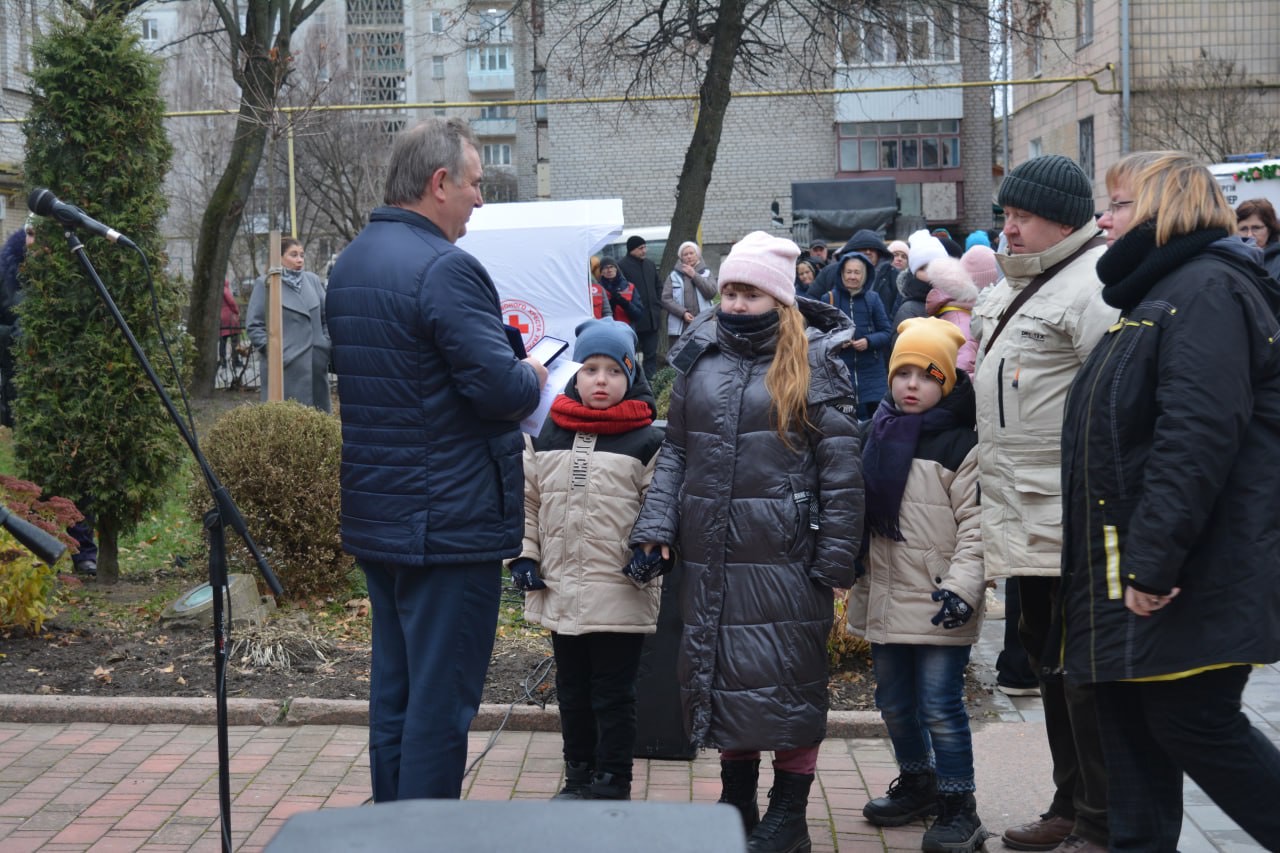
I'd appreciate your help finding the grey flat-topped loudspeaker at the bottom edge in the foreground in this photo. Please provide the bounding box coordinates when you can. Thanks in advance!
[266,799,746,853]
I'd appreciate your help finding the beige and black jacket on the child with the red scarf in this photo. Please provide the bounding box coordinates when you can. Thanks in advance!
[520,421,662,635]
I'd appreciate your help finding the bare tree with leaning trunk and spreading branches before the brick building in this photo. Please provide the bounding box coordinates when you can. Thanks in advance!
[468,0,992,272]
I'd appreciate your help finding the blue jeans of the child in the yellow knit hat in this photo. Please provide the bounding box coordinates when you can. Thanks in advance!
[872,643,974,793]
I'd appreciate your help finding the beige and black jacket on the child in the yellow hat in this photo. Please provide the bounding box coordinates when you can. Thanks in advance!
[847,412,986,646]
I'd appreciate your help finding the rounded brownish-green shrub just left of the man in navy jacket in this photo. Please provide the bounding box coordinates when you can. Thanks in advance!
[187,401,352,601]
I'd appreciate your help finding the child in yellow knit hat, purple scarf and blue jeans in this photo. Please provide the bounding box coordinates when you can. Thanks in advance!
[849,318,986,850]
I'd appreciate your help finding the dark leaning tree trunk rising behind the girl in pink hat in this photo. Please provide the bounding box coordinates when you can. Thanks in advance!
[658,0,746,280]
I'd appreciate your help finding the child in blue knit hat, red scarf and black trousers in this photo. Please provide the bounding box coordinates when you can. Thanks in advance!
[509,320,663,799]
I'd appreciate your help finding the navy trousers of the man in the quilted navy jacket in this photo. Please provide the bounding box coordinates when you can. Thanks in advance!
[360,560,502,803]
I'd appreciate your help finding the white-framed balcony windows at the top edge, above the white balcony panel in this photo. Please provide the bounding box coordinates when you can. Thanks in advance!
[840,4,960,65]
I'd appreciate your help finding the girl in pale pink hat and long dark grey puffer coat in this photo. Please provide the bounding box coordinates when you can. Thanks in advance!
[631,232,863,853]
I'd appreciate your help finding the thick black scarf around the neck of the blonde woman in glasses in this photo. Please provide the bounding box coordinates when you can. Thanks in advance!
[1098,219,1228,311]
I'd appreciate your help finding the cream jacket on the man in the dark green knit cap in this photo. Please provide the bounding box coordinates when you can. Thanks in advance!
[970,223,1120,578]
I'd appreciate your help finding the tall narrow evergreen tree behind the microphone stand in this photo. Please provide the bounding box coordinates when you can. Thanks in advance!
[14,0,186,584]
